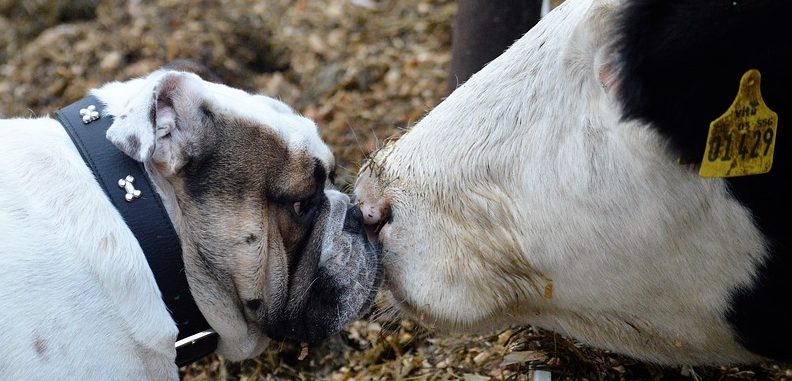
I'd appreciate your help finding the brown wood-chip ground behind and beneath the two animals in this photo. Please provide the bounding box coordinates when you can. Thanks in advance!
[0,0,792,381]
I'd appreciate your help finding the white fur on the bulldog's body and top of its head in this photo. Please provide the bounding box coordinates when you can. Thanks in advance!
[0,72,332,380]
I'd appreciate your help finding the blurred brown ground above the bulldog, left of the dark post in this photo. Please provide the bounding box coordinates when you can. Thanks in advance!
[0,0,455,189]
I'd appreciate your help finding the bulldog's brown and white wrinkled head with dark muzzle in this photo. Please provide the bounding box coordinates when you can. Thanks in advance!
[94,71,378,359]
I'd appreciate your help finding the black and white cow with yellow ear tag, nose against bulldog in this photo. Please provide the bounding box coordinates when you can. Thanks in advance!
[355,0,792,365]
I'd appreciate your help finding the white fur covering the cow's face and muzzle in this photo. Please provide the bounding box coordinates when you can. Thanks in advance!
[356,0,765,364]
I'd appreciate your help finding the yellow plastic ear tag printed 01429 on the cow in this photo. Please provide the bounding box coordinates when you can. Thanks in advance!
[699,69,778,177]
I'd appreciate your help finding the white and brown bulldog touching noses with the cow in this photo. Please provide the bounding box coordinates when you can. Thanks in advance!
[0,69,378,380]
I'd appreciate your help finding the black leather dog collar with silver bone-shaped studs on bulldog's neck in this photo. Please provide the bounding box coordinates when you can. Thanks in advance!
[55,96,217,366]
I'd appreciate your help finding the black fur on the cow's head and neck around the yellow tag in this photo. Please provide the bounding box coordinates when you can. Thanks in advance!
[614,0,792,361]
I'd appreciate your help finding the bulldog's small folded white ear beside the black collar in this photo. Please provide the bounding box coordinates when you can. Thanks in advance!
[107,72,209,175]
